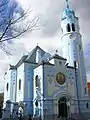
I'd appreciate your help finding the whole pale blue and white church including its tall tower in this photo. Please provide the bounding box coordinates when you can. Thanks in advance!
[3,0,90,120]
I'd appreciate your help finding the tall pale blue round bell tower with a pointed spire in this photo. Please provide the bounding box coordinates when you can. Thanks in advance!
[61,0,88,97]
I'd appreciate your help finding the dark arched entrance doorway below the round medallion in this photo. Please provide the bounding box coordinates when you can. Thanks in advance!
[58,97,68,118]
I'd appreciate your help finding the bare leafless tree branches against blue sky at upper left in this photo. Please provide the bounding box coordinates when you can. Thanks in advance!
[0,0,39,54]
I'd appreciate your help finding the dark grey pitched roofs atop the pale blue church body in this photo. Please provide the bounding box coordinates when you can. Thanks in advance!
[10,46,67,69]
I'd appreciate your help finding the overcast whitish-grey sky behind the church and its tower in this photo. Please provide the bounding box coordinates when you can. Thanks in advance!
[0,0,90,92]
